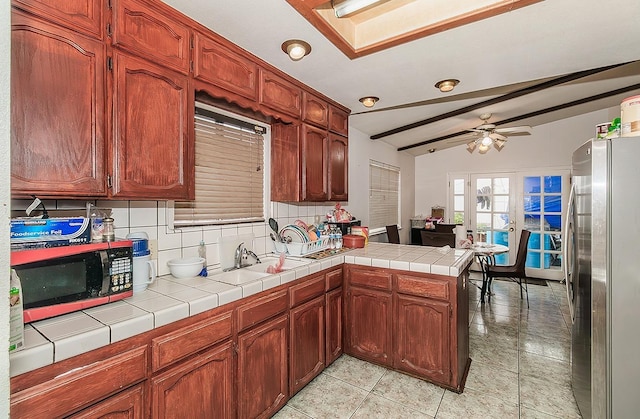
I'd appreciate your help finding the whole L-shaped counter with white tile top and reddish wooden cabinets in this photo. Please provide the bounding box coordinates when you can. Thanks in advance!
[11,243,473,418]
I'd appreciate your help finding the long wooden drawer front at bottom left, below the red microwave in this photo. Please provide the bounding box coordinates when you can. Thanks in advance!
[11,346,147,418]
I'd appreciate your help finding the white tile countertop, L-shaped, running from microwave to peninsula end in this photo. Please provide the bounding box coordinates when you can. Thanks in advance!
[9,243,473,377]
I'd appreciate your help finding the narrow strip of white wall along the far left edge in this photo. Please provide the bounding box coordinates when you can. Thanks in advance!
[0,1,11,417]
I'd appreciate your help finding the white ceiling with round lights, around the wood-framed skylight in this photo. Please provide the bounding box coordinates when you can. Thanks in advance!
[164,0,640,155]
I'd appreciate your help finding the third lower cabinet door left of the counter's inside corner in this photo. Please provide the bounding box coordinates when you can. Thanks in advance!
[238,315,289,419]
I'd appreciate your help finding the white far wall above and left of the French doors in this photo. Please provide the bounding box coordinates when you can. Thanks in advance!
[415,108,620,216]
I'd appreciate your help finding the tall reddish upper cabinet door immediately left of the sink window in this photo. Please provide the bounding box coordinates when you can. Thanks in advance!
[112,52,194,199]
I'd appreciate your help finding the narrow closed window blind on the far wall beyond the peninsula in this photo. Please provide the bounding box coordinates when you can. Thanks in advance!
[369,160,400,232]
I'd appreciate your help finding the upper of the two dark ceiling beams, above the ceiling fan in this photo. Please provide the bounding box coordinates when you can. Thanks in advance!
[369,62,629,141]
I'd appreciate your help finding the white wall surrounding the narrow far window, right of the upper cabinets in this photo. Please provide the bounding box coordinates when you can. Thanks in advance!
[348,127,415,243]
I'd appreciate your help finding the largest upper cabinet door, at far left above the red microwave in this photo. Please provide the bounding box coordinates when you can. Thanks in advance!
[11,10,106,197]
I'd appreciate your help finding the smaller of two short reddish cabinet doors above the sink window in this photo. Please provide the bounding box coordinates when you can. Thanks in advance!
[259,69,302,118]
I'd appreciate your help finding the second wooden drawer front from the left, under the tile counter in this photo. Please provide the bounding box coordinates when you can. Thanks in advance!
[151,312,232,371]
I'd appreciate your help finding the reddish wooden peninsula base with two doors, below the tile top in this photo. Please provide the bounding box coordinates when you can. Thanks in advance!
[344,265,471,392]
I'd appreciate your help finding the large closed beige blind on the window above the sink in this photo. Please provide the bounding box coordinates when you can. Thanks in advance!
[174,109,266,227]
